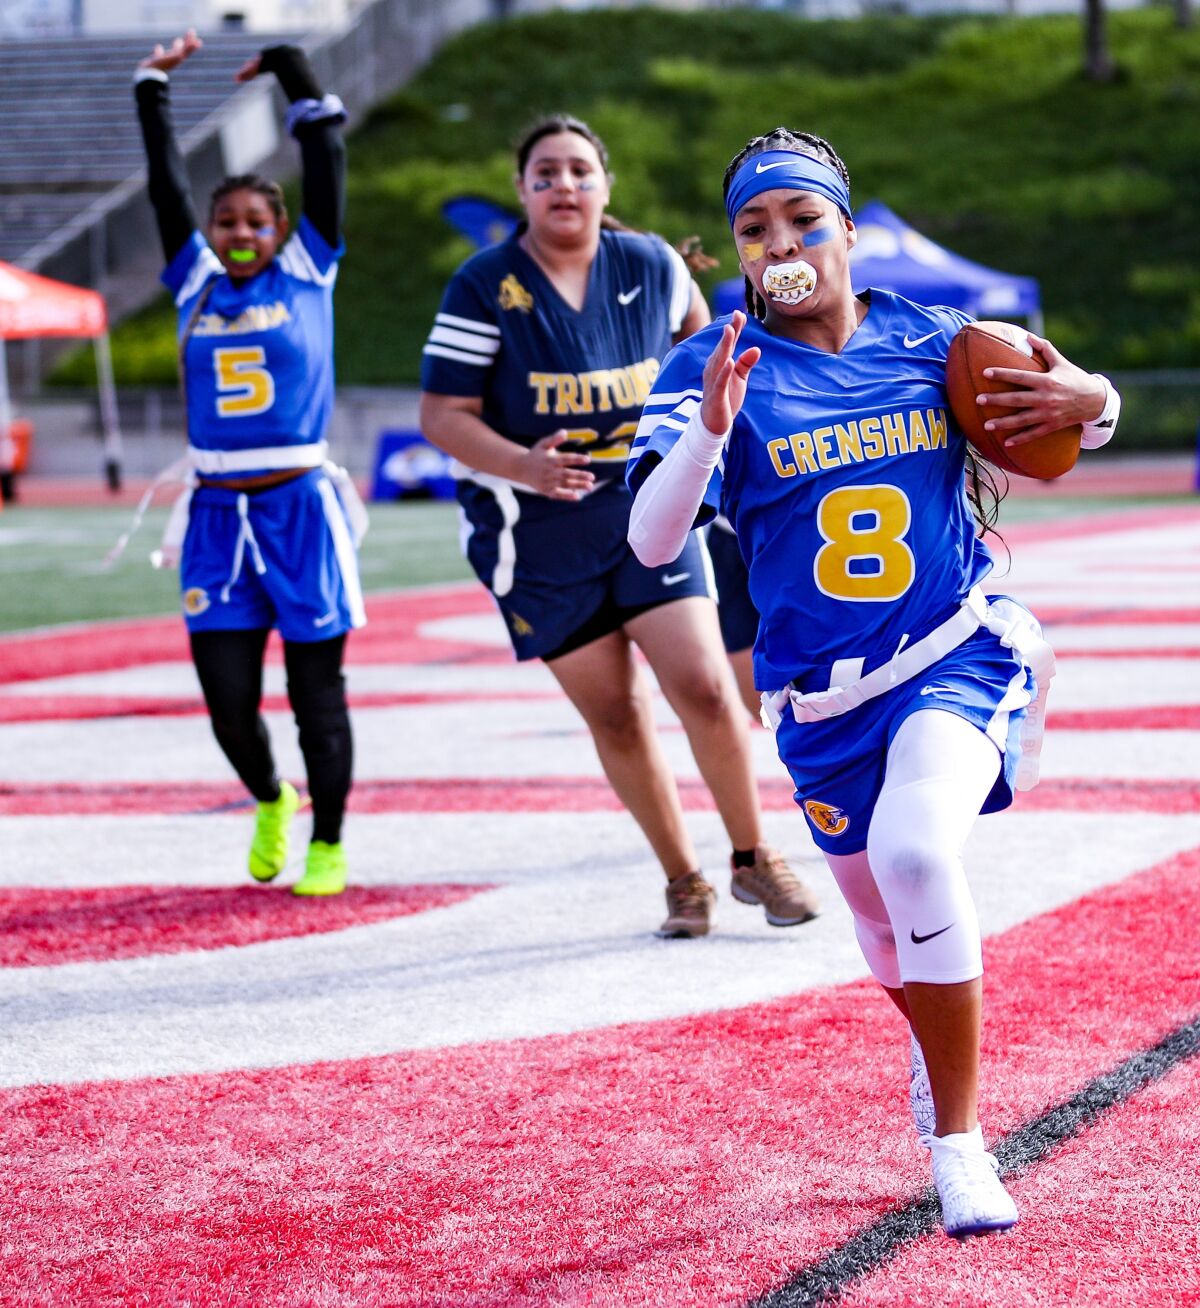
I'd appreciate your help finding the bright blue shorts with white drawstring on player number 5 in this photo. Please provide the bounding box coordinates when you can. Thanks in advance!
[179,468,366,642]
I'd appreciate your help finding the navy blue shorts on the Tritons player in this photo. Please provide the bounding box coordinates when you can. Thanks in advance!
[459,483,713,661]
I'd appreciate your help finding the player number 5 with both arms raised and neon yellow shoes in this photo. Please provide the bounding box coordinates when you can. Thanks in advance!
[135,31,365,895]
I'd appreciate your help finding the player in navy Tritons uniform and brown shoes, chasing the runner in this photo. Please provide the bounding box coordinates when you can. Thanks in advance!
[421,116,817,937]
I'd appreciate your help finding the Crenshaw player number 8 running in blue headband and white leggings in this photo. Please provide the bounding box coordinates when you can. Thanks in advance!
[628,128,1119,1235]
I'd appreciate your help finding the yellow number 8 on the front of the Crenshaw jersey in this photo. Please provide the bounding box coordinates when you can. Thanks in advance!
[813,485,916,603]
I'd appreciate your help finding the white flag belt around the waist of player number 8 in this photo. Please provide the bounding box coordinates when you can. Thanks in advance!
[762,586,1055,790]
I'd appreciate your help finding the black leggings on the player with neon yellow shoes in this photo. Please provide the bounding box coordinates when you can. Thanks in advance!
[191,628,353,844]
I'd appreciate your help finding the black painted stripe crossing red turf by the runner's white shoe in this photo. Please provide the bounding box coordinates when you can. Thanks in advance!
[747,1018,1200,1308]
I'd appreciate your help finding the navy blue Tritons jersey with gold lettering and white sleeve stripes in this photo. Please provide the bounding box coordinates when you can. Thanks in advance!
[421,230,692,514]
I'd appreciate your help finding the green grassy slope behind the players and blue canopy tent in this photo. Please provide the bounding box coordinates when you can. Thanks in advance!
[62,8,1200,405]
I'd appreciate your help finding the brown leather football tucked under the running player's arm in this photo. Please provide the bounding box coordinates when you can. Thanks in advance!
[946,322,1081,481]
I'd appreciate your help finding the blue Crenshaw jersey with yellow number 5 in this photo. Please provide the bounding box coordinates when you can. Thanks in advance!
[162,217,343,476]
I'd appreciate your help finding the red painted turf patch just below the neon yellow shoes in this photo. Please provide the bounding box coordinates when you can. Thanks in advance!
[0,884,491,968]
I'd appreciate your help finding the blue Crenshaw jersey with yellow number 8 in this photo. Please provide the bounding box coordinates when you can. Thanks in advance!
[628,290,992,691]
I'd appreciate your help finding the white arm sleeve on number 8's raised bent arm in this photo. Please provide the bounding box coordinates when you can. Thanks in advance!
[629,408,729,568]
